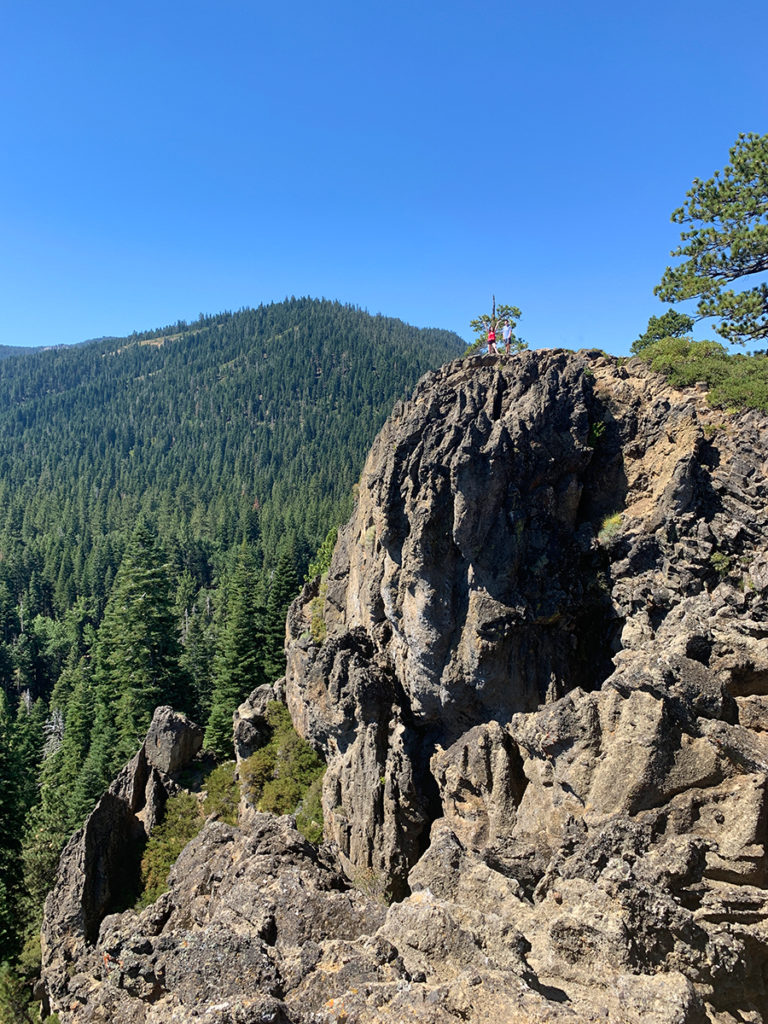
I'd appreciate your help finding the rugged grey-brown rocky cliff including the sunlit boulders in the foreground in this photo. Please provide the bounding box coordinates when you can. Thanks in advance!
[44,351,768,1024]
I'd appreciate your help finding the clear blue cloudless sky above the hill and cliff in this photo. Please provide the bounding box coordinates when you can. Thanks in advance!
[0,0,768,354]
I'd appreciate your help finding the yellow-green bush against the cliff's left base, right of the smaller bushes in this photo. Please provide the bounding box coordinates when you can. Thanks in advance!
[240,701,326,842]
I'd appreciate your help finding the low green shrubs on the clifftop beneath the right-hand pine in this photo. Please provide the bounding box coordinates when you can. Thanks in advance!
[641,338,768,413]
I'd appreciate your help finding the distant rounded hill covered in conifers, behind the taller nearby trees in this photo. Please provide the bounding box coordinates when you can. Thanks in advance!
[0,299,464,610]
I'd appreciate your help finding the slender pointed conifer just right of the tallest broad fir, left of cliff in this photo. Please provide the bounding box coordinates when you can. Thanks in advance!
[206,544,266,757]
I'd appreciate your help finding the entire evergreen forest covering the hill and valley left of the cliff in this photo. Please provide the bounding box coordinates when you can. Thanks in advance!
[0,299,465,985]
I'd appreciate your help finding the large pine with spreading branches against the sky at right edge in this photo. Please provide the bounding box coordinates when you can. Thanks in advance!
[655,132,768,344]
